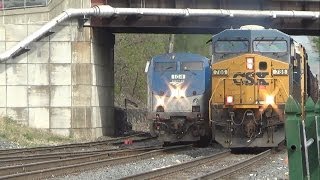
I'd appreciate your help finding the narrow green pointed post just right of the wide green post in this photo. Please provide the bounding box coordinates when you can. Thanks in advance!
[305,97,319,180]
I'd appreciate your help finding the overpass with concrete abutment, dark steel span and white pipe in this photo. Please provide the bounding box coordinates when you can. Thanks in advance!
[0,0,320,137]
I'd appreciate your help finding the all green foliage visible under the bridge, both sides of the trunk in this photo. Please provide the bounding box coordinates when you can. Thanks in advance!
[114,34,211,108]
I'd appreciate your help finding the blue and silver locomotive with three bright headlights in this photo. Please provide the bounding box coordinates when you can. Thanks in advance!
[146,53,211,143]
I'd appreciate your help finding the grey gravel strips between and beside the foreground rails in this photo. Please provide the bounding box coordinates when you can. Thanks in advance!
[58,147,289,180]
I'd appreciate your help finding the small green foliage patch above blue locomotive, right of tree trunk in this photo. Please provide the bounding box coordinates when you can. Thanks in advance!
[174,34,212,58]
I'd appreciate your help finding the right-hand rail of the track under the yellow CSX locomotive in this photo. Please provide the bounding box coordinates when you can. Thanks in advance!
[193,149,271,180]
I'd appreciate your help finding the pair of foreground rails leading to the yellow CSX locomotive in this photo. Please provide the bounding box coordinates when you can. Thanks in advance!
[122,150,271,180]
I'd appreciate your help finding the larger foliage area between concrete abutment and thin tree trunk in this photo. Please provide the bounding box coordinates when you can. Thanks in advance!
[114,34,169,105]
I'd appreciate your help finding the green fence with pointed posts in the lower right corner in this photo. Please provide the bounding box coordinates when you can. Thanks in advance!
[285,96,320,180]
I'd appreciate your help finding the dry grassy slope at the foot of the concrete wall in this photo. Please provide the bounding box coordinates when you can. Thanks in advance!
[0,117,75,147]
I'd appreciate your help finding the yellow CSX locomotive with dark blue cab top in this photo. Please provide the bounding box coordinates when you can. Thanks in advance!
[209,26,319,148]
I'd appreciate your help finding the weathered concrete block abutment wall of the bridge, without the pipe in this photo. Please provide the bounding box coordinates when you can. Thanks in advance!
[0,0,114,138]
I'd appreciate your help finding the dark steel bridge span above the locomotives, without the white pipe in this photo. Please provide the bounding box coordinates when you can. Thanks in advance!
[90,0,320,35]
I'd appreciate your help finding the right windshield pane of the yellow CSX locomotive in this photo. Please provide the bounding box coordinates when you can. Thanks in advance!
[253,40,288,53]
